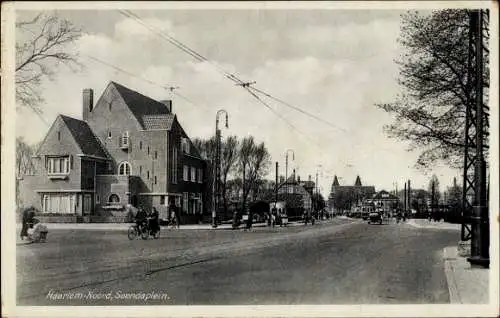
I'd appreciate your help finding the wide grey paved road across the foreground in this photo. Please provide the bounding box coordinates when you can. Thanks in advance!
[17,220,458,305]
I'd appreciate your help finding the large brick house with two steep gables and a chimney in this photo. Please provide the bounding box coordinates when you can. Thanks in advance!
[20,82,210,222]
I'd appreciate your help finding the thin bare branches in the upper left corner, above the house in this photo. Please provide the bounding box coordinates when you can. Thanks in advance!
[15,14,81,110]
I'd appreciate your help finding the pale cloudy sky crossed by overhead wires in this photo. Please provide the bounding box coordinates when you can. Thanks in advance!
[16,6,460,195]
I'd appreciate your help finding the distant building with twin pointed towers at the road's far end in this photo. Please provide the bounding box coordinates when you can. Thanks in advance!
[328,176,375,210]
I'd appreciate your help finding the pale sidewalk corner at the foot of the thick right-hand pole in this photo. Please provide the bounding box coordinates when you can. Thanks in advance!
[443,246,490,304]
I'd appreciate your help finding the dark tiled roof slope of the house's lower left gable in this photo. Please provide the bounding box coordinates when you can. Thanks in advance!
[60,115,108,158]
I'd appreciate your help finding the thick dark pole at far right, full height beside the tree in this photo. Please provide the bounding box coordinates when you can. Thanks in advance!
[467,10,490,267]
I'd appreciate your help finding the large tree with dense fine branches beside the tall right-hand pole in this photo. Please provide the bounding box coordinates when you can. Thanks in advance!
[376,10,489,168]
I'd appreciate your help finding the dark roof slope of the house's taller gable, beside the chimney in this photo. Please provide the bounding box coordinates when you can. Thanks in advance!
[111,82,171,128]
